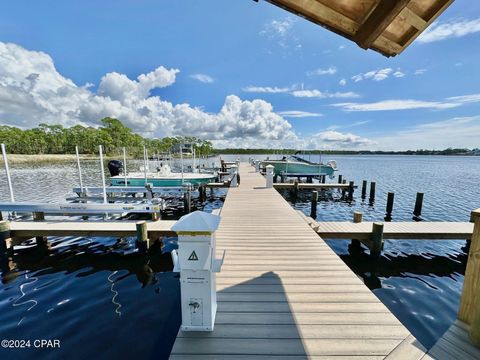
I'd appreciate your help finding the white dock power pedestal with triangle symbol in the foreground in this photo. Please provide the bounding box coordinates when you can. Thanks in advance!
[172,211,225,331]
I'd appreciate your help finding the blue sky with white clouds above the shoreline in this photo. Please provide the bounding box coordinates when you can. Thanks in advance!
[0,0,480,149]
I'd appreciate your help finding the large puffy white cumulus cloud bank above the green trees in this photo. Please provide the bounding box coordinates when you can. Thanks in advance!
[0,42,297,142]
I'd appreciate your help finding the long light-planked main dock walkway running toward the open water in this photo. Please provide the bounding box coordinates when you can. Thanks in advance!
[171,163,425,360]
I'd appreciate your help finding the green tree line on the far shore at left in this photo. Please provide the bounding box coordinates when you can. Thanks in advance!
[0,118,213,156]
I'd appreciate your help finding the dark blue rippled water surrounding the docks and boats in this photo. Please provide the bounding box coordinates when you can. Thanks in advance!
[0,156,480,359]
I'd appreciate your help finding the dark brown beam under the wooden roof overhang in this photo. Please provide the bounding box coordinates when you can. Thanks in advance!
[354,0,410,49]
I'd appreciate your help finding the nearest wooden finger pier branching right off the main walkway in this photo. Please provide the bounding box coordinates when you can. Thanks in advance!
[310,221,473,240]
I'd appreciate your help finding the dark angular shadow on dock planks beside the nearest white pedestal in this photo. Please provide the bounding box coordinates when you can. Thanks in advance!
[170,272,308,360]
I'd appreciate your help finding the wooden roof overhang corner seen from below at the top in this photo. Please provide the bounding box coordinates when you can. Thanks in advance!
[254,0,454,57]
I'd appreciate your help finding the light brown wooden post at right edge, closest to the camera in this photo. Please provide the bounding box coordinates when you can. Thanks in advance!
[457,209,480,334]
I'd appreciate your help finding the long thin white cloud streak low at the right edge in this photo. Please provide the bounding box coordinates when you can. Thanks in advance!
[332,94,480,111]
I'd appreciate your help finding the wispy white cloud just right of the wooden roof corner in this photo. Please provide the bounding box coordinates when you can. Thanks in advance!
[417,18,480,43]
